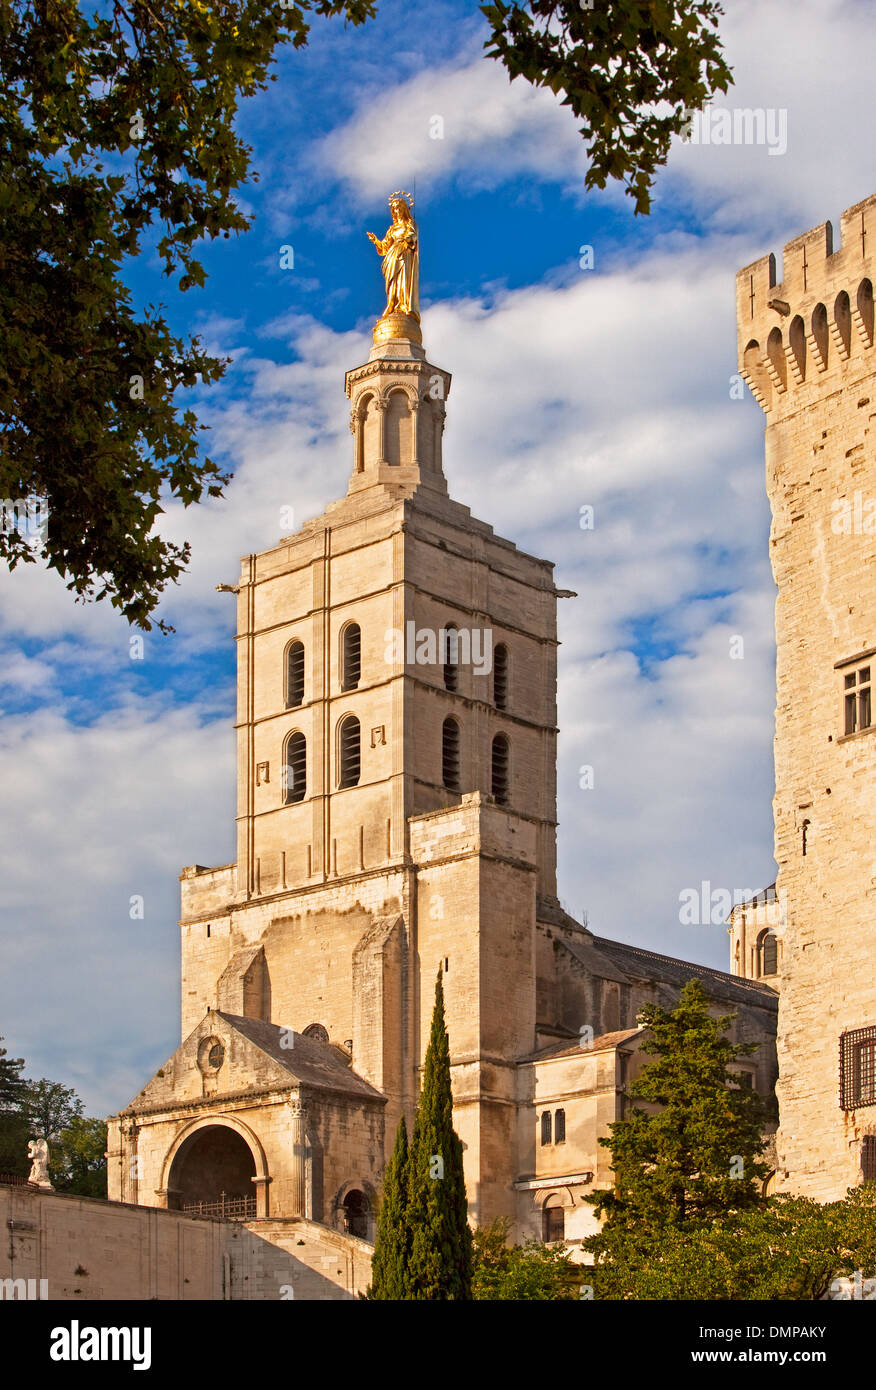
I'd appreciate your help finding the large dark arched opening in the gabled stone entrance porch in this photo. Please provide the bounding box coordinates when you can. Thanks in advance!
[168,1125,256,1220]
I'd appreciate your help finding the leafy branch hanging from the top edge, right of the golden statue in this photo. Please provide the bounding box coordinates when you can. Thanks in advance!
[481,0,731,213]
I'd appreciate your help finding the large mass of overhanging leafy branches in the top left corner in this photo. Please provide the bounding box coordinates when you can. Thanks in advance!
[0,0,374,628]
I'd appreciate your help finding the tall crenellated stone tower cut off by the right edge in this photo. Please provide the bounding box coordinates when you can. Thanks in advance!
[737,196,876,1200]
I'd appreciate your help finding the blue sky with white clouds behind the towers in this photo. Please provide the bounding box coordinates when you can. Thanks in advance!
[0,0,876,1113]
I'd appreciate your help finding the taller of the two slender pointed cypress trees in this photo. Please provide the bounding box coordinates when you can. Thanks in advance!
[405,972,471,1300]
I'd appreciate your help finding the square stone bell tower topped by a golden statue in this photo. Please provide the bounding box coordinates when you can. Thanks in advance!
[125,195,567,1220]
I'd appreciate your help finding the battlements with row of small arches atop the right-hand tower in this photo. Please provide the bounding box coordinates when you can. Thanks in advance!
[736,195,876,411]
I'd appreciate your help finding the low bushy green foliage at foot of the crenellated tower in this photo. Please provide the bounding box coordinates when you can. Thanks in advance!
[588,1184,876,1301]
